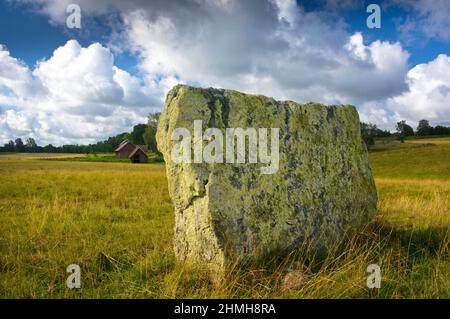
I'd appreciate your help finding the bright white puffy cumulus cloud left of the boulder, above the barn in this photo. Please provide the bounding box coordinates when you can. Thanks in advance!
[0,40,161,144]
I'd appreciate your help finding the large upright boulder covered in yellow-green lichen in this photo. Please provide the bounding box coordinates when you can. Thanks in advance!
[156,85,377,267]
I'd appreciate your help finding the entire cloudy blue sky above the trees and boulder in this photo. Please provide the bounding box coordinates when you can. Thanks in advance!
[0,0,450,144]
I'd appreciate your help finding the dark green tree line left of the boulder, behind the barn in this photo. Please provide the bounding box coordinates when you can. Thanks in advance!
[0,113,160,154]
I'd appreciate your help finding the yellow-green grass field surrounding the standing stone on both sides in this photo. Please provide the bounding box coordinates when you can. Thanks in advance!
[0,138,450,298]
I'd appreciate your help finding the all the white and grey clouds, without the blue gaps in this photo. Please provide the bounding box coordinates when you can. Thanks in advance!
[0,0,450,141]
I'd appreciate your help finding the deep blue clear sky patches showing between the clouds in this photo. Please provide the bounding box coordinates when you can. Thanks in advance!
[0,0,450,71]
